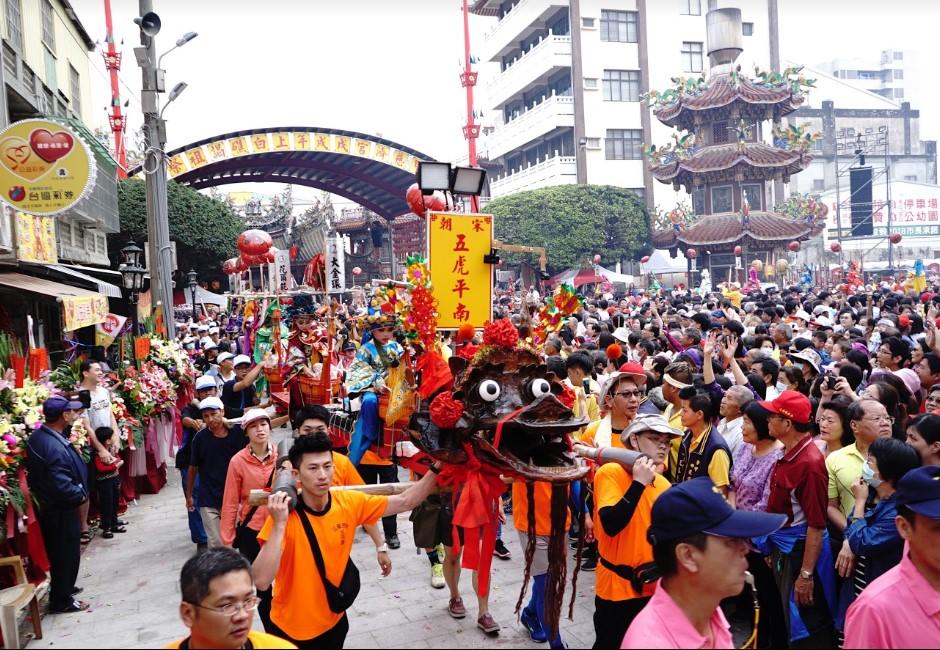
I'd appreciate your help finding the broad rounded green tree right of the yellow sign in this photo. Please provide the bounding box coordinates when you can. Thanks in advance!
[486,185,650,272]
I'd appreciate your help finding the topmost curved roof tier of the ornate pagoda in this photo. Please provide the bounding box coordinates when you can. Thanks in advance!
[653,72,804,131]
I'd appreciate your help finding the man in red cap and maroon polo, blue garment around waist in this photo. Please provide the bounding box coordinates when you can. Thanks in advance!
[755,390,835,648]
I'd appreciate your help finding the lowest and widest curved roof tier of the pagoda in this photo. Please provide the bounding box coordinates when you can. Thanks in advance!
[652,210,826,248]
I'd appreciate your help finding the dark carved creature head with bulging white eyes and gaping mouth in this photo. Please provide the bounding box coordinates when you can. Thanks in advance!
[409,320,586,483]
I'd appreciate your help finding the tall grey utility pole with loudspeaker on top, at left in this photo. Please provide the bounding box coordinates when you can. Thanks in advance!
[134,0,176,339]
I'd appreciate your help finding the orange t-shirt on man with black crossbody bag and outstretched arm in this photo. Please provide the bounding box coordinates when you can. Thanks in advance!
[258,490,388,639]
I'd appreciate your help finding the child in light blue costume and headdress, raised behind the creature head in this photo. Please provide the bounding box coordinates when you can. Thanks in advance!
[346,311,405,466]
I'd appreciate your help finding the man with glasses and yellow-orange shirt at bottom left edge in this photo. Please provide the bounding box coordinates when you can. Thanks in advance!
[167,548,297,650]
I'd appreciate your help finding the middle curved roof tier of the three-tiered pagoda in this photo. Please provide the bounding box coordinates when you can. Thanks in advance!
[650,142,813,191]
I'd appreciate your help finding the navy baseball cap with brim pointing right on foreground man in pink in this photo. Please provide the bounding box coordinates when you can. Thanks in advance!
[646,476,787,546]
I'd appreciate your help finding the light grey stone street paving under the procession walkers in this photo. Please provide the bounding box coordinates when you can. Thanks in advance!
[35,422,594,648]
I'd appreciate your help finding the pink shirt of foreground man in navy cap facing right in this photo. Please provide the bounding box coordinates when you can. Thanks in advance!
[620,580,734,648]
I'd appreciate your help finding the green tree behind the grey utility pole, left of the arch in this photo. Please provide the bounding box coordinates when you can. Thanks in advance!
[108,178,244,277]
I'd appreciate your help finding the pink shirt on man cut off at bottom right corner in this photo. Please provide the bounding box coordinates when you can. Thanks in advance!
[844,549,940,648]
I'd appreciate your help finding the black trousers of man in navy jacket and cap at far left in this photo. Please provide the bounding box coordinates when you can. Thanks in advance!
[39,506,82,609]
